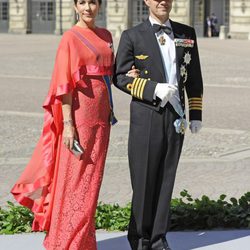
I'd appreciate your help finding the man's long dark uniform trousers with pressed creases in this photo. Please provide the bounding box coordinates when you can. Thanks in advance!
[128,102,184,250]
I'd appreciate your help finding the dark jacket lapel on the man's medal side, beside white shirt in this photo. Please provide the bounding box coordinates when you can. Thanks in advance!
[170,20,186,83]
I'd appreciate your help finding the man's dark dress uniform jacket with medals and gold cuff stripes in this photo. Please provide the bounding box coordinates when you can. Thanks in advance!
[114,20,203,120]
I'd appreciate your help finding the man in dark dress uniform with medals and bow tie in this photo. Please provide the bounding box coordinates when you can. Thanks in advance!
[114,0,203,250]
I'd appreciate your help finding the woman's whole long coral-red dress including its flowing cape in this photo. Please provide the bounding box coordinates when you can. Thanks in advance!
[11,26,114,250]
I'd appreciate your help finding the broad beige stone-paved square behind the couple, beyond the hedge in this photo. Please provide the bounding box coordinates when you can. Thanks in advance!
[0,34,250,208]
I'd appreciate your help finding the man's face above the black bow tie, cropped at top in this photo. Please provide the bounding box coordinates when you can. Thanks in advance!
[144,0,173,20]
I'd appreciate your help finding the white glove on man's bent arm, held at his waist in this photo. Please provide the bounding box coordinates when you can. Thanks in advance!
[154,83,178,107]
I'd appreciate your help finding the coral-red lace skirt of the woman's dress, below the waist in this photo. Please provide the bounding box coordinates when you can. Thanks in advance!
[44,77,110,250]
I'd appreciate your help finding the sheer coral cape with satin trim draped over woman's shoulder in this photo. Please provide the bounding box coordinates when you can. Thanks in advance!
[11,26,113,231]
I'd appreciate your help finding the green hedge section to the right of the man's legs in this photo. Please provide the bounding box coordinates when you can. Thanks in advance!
[170,190,250,230]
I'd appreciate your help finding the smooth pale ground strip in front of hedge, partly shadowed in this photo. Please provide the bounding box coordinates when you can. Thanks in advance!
[0,230,250,250]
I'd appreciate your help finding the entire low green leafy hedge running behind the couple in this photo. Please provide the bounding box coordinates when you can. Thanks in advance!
[0,190,250,234]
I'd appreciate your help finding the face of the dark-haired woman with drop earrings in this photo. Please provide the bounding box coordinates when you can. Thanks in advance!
[75,0,100,26]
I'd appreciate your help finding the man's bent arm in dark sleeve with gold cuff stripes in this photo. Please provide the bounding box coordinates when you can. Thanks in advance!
[113,31,157,103]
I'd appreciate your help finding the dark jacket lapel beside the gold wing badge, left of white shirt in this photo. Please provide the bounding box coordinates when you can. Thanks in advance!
[141,19,166,81]
